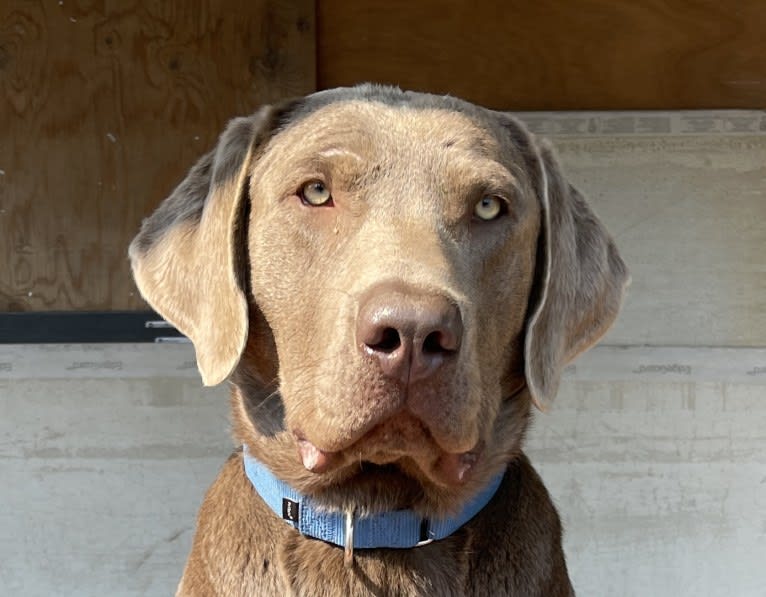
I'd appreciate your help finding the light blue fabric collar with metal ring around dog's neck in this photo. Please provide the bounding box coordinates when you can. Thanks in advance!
[243,446,505,563]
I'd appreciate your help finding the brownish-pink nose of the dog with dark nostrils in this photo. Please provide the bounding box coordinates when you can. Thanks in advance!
[356,285,463,384]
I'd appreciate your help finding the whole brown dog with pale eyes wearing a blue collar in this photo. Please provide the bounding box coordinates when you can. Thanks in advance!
[129,84,629,597]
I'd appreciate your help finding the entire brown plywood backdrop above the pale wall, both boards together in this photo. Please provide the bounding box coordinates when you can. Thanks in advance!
[0,0,766,313]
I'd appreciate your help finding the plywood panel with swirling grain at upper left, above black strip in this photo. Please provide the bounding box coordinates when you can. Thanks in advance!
[0,0,315,311]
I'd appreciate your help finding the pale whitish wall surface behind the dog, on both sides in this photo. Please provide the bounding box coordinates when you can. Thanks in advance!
[0,112,766,597]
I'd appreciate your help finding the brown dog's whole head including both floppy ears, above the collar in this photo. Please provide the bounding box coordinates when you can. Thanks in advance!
[130,86,627,512]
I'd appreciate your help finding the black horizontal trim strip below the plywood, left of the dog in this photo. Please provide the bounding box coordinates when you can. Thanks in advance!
[0,311,183,344]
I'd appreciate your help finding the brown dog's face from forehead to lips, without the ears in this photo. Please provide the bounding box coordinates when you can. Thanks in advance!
[249,101,539,485]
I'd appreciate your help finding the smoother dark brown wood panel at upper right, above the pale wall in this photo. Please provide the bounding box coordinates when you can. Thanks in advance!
[317,0,766,110]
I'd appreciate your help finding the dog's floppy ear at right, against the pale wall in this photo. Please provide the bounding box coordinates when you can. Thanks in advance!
[524,134,630,410]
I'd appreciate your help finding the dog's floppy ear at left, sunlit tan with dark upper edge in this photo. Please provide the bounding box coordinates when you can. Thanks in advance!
[129,106,294,385]
